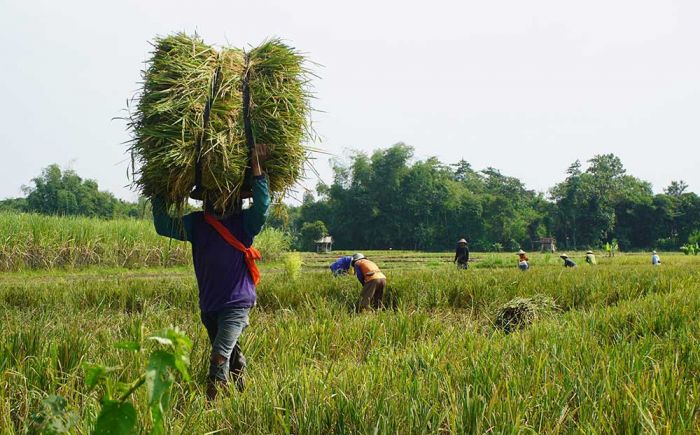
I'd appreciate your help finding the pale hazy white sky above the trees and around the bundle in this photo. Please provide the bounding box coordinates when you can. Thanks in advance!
[0,0,700,199]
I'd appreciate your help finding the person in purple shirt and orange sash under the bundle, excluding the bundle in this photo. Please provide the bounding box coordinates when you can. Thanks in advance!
[153,145,270,400]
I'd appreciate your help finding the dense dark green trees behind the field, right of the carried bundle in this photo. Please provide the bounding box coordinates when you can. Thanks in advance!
[280,143,700,250]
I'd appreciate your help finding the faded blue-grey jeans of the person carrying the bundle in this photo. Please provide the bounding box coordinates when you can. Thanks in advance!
[200,308,250,382]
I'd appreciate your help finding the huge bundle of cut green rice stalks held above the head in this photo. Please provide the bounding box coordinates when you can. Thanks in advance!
[129,33,311,210]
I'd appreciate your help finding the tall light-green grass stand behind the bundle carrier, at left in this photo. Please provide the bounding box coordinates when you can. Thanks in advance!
[0,213,290,271]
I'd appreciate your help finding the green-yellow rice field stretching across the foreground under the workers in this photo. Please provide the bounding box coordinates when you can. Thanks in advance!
[0,215,700,434]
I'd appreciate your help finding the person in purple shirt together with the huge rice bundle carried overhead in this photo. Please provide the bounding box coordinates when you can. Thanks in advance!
[129,34,310,399]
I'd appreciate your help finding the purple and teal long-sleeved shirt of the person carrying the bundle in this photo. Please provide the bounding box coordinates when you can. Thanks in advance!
[153,177,270,312]
